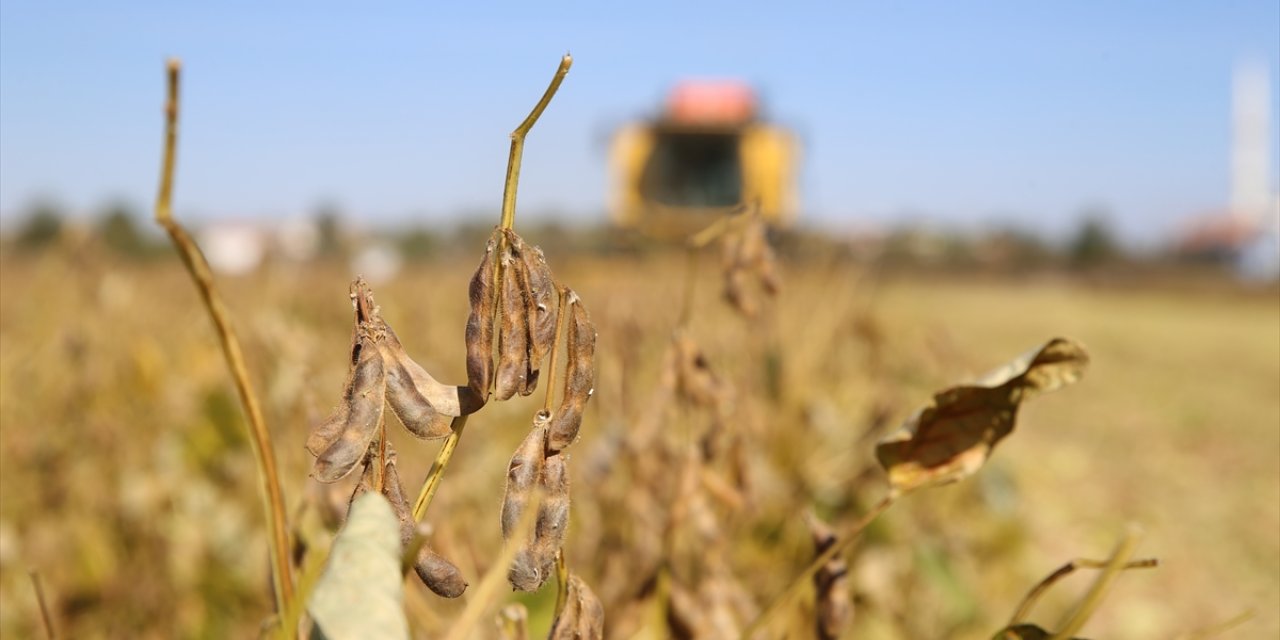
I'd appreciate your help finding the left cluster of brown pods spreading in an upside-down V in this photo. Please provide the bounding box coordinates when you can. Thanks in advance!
[306,279,483,483]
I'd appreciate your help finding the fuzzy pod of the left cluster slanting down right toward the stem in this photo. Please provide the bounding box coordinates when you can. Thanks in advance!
[379,323,462,439]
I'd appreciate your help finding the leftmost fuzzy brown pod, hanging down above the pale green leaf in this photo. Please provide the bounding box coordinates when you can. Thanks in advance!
[308,326,387,483]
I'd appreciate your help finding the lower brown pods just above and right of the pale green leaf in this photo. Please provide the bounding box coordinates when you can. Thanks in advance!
[348,443,467,598]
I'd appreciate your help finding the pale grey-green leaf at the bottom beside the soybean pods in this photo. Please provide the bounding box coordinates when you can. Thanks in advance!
[307,492,408,640]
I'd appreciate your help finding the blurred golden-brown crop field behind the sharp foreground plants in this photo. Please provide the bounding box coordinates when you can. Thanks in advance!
[0,237,1280,639]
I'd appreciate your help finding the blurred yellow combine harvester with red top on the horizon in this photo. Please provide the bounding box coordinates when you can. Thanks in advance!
[609,82,799,238]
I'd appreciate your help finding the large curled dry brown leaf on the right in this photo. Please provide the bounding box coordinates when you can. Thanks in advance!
[876,338,1089,493]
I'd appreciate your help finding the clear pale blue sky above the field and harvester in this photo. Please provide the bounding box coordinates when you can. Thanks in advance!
[0,0,1280,238]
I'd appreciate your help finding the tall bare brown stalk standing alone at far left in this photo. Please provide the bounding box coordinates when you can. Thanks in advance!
[155,59,293,614]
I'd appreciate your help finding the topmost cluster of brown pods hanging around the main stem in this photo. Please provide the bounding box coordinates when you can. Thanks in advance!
[466,229,557,401]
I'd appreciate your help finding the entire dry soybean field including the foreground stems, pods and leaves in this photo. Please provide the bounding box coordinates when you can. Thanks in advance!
[0,56,1280,639]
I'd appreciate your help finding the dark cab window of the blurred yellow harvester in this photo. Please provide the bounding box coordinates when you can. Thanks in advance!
[640,132,742,207]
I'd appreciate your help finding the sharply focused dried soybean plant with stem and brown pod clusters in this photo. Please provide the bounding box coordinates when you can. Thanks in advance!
[299,55,603,637]
